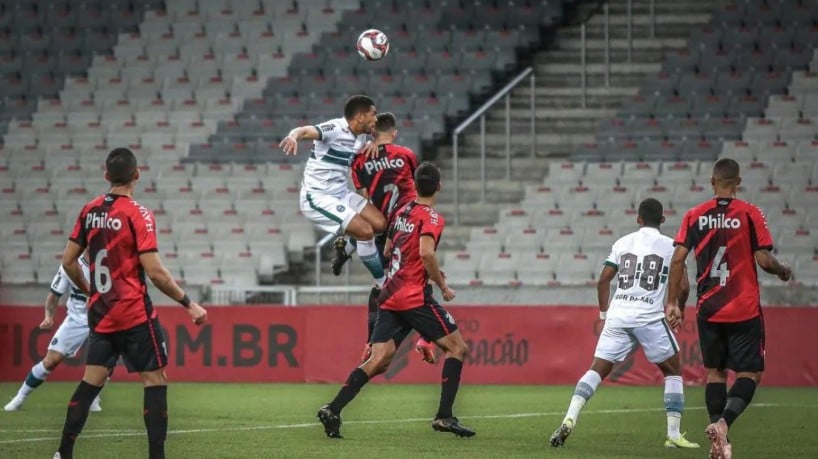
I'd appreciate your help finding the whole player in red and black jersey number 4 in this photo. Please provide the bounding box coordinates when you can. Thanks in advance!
[667,158,792,459]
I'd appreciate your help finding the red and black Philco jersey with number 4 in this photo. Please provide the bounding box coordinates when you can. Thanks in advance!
[674,198,773,322]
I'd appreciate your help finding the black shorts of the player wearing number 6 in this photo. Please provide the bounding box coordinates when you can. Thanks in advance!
[85,319,168,373]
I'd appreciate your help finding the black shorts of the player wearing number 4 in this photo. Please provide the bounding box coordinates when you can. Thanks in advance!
[697,316,764,373]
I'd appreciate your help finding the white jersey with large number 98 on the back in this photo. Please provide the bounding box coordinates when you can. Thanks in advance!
[605,227,673,328]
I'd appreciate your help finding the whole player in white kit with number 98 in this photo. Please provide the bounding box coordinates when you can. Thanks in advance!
[551,198,699,448]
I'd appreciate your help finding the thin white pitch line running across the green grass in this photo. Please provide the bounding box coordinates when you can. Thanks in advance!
[0,403,804,444]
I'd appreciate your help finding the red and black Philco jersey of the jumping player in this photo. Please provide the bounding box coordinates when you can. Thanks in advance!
[352,143,418,222]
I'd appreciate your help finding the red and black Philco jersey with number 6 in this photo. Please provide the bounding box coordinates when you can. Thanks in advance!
[70,194,158,333]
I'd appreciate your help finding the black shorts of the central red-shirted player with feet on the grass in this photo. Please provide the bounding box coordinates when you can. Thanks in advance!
[372,287,457,347]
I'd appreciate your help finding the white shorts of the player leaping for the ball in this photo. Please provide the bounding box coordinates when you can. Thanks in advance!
[300,188,367,234]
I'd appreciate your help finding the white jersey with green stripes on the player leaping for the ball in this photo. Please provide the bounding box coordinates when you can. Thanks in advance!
[302,118,369,195]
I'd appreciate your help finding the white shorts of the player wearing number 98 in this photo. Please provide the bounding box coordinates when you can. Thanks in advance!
[594,319,679,363]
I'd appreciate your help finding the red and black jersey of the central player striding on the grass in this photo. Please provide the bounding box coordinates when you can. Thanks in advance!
[379,201,446,311]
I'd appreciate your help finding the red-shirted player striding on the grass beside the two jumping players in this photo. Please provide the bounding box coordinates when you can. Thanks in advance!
[318,163,475,438]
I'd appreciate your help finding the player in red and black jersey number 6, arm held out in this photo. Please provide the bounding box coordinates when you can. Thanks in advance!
[54,148,207,459]
